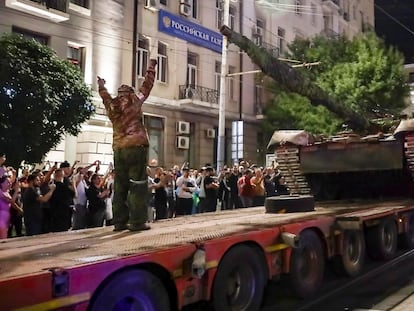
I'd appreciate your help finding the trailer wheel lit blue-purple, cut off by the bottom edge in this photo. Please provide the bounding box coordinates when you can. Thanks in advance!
[88,269,170,311]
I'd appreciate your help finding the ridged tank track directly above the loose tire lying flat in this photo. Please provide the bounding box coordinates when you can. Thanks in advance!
[276,146,310,195]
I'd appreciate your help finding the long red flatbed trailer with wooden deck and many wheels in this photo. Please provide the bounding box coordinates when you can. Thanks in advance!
[0,200,414,310]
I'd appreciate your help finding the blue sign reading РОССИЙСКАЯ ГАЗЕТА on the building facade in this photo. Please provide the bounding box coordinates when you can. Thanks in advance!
[158,10,223,53]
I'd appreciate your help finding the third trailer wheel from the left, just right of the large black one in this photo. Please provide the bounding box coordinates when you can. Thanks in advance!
[289,230,325,298]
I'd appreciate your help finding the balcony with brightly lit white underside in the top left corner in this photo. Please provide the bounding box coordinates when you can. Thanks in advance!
[5,0,69,23]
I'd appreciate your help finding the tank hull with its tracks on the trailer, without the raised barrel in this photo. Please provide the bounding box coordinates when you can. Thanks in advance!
[268,119,414,201]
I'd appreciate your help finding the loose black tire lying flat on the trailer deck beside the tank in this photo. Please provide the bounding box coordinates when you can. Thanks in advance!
[265,195,315,213]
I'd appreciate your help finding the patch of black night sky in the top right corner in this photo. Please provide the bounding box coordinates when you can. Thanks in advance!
[374,0,414,63]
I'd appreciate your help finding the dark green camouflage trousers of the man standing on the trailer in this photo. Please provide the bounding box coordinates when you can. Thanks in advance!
[112,146,148,226]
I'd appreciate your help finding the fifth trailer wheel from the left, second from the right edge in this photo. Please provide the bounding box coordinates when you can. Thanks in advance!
[367,218,398,260]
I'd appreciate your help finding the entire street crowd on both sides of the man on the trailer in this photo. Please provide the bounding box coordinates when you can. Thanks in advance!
[0,154,289,239]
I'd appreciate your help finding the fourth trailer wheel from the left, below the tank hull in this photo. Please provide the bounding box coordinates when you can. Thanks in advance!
[334,230,365,277]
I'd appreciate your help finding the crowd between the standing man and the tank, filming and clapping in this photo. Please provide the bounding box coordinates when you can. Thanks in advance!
[147,161,289,220]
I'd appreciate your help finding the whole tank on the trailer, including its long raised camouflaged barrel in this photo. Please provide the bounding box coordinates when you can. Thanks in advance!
[220,26,414,201]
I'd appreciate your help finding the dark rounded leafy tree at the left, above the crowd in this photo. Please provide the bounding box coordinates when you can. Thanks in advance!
[0,34,95,168]
